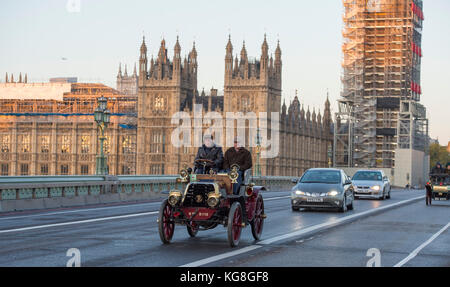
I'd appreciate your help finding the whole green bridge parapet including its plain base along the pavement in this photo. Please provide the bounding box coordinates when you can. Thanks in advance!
[0,175,294,212]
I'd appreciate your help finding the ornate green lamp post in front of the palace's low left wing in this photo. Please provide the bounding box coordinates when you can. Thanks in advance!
[94,96,111,175]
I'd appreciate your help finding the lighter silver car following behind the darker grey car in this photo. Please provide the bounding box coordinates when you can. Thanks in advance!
[352,170,391,200]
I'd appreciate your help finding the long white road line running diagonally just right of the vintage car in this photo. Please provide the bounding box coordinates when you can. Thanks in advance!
[180,196,425,267]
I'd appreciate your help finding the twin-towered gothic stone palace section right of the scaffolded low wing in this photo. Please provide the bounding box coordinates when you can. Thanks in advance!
[136,35,332,176]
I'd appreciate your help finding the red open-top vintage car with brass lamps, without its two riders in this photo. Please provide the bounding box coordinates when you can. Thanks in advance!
[158,163,266,247]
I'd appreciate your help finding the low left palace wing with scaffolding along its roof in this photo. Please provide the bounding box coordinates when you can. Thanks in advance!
[0,84,137,176]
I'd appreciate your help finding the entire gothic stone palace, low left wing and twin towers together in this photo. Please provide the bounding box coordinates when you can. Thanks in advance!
[0,36,333,176]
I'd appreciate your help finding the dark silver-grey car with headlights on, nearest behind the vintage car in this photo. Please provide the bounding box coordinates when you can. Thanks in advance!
[291,168,354,212]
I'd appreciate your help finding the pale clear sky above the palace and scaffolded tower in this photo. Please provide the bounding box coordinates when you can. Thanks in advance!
[0,0,450,144]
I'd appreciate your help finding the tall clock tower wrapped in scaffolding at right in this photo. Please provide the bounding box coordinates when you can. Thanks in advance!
[335,0,423,168]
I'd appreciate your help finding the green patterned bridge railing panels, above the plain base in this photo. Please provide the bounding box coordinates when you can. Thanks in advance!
[0,175,294,200]
